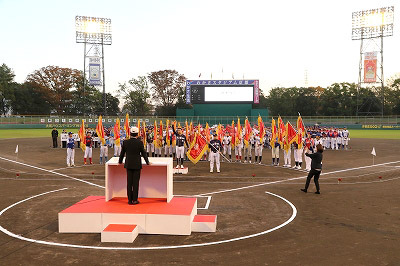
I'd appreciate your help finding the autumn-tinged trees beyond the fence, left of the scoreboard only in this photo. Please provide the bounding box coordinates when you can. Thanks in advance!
[0,64,186,116]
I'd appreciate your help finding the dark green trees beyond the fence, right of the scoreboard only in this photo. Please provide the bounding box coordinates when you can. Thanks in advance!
[261,81,400,116]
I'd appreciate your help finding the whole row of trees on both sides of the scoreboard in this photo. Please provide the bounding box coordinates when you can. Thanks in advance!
[0,64,400,116]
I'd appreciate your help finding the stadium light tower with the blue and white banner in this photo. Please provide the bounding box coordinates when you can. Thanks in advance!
[75,16,112,115]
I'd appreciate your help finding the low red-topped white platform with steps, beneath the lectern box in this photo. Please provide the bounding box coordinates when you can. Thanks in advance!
[58,196,217,242]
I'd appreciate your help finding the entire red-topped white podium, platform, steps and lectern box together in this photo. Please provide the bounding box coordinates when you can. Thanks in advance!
[58,154,217,243]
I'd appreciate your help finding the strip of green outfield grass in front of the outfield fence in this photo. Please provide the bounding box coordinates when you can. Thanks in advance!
[0,128,400,139]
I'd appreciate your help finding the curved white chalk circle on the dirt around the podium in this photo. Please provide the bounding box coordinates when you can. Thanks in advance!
[0,188,297,250]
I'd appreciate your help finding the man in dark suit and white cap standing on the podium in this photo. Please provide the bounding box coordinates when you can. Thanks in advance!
[119,127,150,205]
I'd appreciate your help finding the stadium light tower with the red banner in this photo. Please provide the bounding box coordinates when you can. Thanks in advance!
[351,6,394,116]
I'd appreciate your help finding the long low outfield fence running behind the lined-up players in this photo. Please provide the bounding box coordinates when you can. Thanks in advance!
[0,115,400,128]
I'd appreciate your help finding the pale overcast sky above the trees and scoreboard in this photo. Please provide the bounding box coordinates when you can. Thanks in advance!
[0,0,400,93]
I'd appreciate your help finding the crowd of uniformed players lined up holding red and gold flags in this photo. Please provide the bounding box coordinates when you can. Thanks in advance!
[61,116,349,172]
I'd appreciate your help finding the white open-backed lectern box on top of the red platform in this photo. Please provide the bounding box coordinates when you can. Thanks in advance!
[106,157,174,202]
